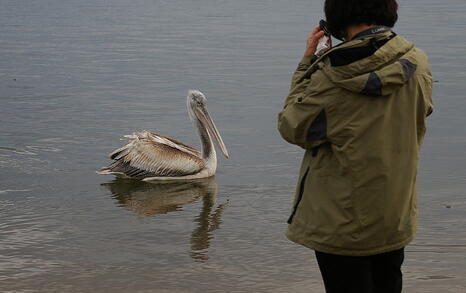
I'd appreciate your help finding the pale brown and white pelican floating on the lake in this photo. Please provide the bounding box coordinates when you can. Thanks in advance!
[97,90,229,181]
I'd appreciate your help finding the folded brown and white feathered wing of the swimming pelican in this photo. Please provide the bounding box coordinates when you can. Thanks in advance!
[101,131,205,179]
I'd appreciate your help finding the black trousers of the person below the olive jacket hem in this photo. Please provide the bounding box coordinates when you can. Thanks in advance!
[316,248,404,293]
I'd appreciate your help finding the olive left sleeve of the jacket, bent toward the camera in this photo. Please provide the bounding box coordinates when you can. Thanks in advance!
[278,57,324,149]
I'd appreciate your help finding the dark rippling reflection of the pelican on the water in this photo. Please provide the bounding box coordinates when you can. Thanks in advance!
[102,177,225,262]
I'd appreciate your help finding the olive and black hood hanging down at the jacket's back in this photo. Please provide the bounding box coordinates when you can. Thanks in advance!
[322,31,418,96]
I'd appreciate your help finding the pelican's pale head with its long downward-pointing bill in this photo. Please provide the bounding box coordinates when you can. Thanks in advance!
[187,90,230,158]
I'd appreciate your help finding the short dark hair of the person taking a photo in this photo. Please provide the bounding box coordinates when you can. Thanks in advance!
[324,0,398,37]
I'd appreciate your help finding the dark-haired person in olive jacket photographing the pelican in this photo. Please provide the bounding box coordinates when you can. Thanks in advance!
[278,0,433,293]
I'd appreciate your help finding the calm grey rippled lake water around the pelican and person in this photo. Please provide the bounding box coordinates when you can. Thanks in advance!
[0,0,466,293]
